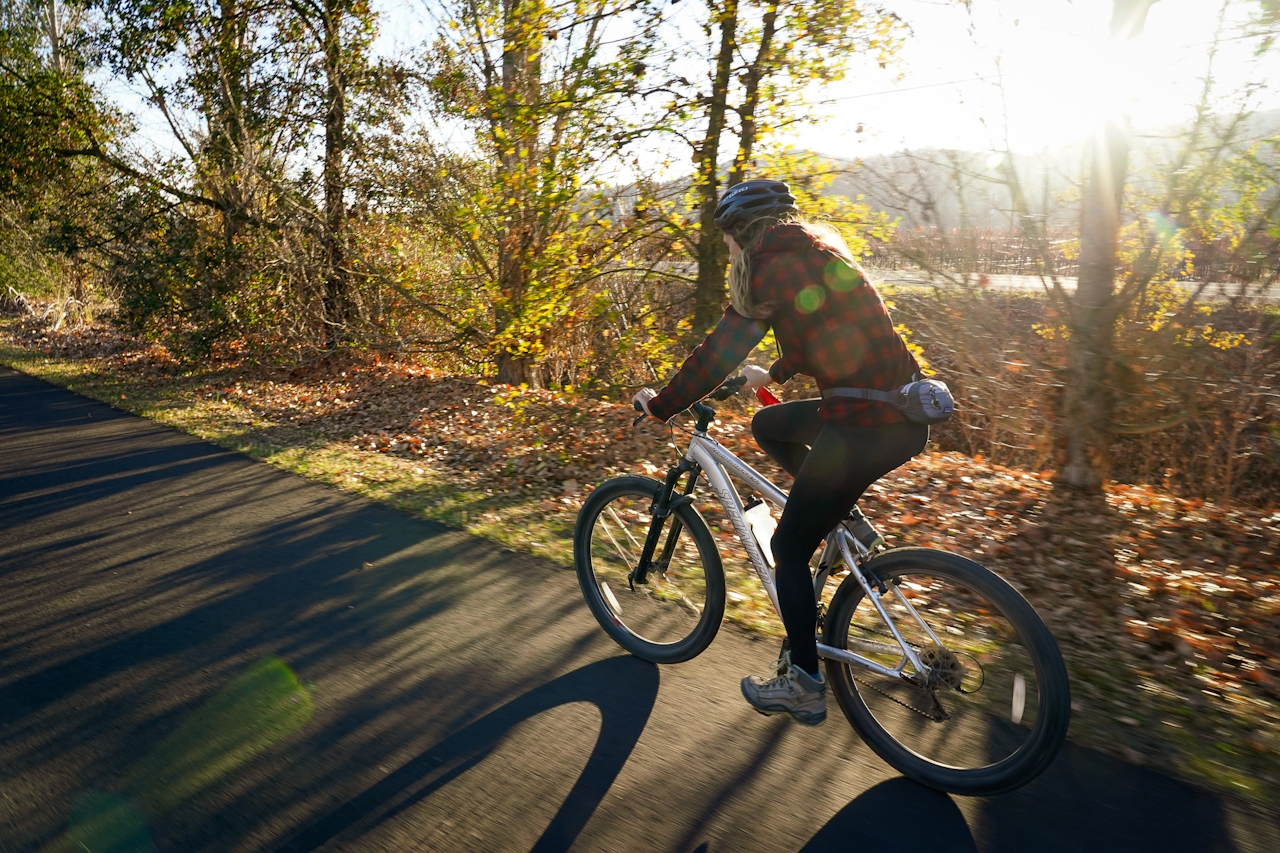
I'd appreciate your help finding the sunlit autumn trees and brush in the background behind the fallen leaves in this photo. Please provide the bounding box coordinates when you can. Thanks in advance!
[0,0,1280,503]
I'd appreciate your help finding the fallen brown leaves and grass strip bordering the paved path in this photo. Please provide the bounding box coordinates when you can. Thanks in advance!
[0,321,1280,803]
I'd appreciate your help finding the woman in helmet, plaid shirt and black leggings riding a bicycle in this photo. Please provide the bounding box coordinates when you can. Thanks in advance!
[635,181,929,725]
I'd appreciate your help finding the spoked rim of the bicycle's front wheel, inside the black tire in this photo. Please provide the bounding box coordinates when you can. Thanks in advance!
[590,494,708,646]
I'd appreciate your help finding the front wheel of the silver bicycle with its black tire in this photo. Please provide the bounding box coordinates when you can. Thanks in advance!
[573,476,724,663]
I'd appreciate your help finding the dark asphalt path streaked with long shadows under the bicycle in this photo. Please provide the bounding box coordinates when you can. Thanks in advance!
[0,369,1280,853]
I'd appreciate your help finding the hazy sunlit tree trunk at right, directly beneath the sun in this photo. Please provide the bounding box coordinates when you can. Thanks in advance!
[1057,0,1156,492]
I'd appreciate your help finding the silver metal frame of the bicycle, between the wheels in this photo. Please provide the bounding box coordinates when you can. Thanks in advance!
[685,419,941,679]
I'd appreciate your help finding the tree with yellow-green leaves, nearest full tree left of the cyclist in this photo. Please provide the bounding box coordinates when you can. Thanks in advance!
[407,0,655,387]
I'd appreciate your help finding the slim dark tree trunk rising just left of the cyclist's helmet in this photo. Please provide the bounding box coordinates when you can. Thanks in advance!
[691,0,737,337]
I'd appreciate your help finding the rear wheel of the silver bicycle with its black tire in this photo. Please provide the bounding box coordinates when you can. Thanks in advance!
[823,548,1071,795]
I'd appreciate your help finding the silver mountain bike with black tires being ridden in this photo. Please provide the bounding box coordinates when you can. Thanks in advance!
[573,377,1071,795]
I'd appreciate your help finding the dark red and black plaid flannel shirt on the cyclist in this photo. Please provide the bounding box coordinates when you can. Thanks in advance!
[649,224,919,427]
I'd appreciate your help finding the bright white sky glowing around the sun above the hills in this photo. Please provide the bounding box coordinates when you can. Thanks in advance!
[108,0,1280,168]
